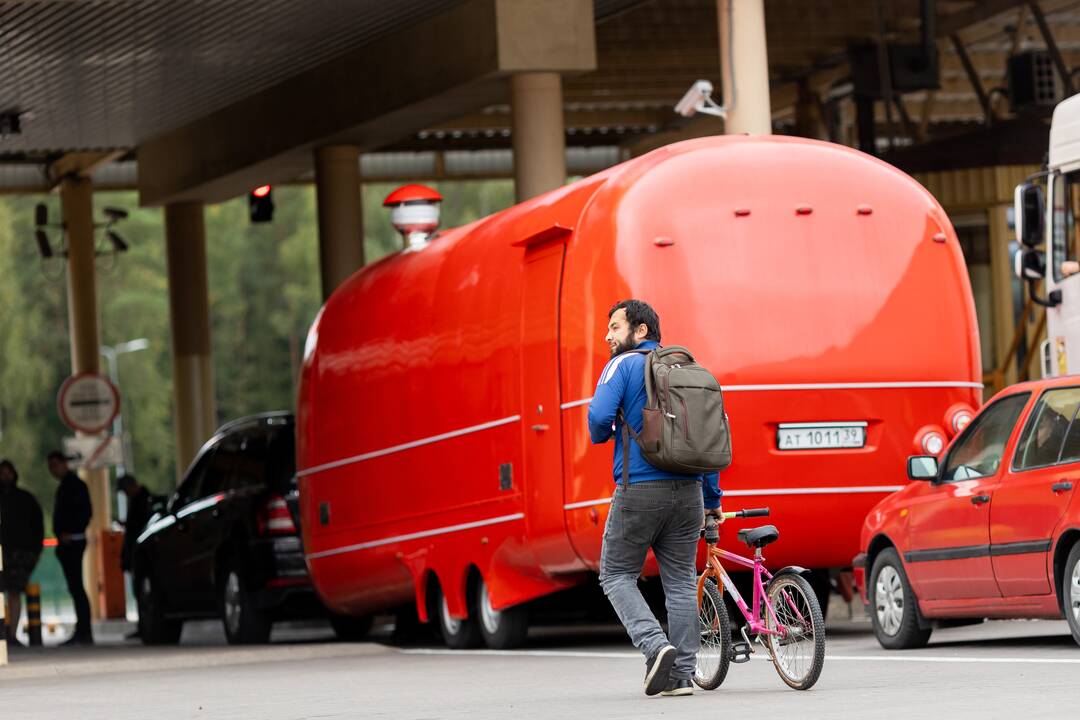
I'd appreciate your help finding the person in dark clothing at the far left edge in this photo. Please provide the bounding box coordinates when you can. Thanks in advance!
[0,460,45,644]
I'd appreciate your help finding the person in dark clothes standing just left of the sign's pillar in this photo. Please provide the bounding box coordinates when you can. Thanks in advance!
[48,450,94,644]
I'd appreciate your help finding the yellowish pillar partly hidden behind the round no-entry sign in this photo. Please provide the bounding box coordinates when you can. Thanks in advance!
[60,175,112,617]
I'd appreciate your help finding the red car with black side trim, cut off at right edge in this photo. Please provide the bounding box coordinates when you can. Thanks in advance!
[854,376,1080,649]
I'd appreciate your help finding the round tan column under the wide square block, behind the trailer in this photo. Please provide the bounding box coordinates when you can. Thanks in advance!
[510,72,566,202]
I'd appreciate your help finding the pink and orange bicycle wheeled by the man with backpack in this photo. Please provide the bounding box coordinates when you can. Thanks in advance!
[693,507,825,690]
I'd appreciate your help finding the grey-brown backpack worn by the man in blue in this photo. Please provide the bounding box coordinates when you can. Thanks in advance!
[619,345,731,486]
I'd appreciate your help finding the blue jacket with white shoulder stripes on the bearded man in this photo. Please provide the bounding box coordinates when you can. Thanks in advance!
[589,340,724,510]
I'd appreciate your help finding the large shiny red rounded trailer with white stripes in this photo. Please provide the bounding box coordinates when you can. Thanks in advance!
[297,136,982,647]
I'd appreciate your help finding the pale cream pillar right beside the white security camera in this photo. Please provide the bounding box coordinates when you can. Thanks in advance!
[717,0,772,135]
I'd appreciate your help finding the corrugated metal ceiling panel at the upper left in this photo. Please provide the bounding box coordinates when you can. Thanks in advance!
[0,0,460,157]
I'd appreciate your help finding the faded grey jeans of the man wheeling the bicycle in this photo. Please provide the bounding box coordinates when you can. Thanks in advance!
[600,480,704,678]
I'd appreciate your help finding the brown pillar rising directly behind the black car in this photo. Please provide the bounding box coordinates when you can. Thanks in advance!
[165,202,217,477]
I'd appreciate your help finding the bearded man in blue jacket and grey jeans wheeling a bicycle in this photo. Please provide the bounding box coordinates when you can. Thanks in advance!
[589,300,721,695]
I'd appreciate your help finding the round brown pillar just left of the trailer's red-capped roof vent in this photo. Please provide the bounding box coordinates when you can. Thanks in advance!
[315,145,364,300]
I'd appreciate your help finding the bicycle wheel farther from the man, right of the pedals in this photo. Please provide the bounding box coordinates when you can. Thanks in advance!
[766,574,825,690]
